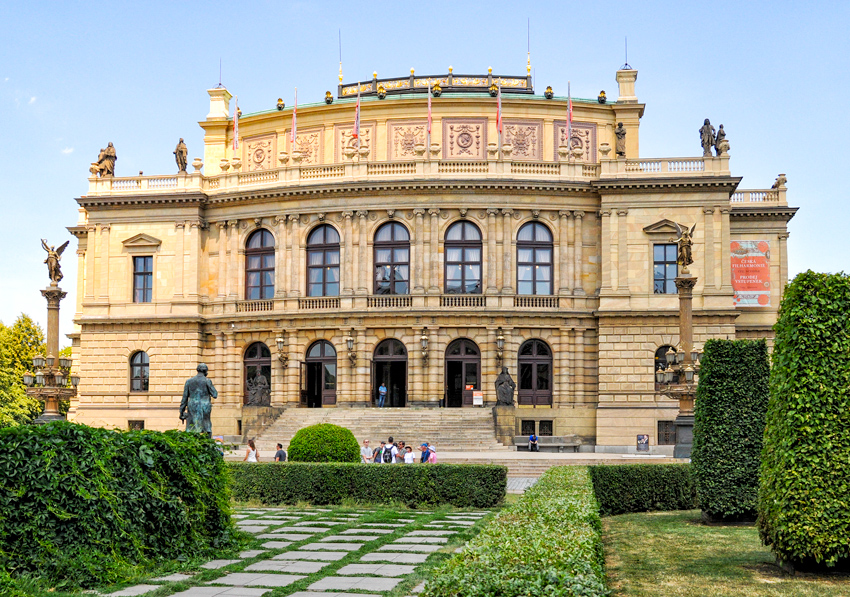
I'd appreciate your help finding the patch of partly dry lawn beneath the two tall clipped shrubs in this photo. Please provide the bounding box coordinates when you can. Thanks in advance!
[603,510,850,597]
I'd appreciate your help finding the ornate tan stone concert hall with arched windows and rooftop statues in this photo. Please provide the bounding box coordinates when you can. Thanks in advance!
[69,69,796,452]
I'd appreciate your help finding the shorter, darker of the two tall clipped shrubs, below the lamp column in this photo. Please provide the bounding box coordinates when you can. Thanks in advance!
[691,340,770,520]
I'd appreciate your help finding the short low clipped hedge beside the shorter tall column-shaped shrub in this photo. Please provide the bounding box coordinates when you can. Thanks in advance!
[588,464,697,516]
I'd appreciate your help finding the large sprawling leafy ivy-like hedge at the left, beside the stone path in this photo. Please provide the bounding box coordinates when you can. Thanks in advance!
[0,422,235,587]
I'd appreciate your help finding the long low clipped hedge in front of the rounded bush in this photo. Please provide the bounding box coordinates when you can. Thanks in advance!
[228,462,507,508]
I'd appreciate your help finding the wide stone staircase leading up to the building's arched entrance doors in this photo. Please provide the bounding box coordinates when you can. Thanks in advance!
[248,407,506,455]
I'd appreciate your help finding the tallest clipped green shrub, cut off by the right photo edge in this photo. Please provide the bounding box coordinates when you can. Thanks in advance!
[758,271,850,568]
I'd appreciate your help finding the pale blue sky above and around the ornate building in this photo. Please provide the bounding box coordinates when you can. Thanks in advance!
[0,0,850,344]
